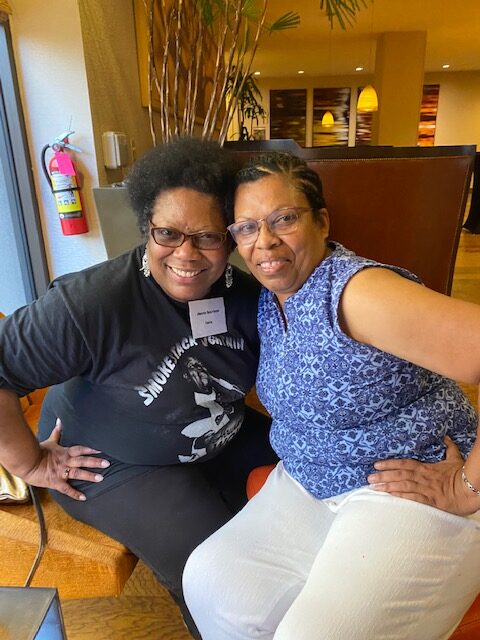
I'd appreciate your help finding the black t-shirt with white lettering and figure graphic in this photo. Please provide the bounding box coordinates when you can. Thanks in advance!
[0,247,259,465]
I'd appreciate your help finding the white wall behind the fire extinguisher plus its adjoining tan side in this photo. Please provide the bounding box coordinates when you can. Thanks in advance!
[10,0,152,278]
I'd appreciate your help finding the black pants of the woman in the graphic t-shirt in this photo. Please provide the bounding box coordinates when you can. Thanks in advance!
[39,397,278,637]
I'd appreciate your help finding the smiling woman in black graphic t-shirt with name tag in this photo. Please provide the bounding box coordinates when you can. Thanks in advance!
[0,138,276,631]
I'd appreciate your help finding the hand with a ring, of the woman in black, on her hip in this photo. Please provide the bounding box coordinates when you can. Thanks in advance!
[23,418,110,500]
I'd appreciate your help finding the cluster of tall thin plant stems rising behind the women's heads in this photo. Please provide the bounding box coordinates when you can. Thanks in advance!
[144,0,300,143]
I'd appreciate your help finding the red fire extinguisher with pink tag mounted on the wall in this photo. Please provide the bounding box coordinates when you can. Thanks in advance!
[42,131,88,236]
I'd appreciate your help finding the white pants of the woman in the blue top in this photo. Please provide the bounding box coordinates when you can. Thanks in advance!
[183,463,480,640]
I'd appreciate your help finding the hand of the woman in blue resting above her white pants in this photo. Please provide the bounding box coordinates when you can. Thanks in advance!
[368,436,479,516]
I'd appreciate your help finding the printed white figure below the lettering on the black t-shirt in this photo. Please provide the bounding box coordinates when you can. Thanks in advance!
[178,357,243,462]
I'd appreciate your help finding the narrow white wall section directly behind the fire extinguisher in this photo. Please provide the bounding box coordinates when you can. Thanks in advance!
[10,0,106,278]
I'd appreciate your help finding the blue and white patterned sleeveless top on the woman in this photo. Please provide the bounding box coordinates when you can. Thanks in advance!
[257,243,476,498]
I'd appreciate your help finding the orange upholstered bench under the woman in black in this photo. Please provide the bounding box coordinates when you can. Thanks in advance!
[0,324,137,599]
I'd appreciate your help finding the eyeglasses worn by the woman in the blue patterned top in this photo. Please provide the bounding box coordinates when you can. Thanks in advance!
[227,207,315,246]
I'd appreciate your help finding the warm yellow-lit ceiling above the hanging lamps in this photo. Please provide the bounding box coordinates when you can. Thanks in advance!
[253,0,480,77]
